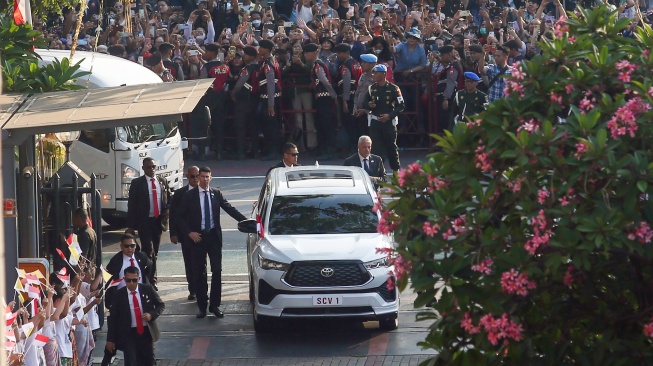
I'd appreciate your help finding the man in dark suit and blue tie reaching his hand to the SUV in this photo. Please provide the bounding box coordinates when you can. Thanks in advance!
[175,167,246,318]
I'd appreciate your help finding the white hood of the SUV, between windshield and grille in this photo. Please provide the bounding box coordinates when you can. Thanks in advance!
[261,233,392,263]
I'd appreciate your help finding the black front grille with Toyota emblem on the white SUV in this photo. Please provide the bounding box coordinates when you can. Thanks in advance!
[284,262,371,287]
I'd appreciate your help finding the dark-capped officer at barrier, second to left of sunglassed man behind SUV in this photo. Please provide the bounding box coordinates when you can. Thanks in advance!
[231,46,259,160]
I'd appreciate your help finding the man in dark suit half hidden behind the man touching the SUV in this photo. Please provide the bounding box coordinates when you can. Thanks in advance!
[170,166,200,300]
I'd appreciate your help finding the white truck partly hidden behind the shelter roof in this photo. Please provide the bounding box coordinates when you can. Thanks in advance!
[37,50,186,227]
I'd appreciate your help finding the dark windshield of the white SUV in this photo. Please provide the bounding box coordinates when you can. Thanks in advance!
[268,194,379,235]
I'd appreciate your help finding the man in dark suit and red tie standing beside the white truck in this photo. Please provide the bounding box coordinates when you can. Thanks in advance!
[125,158,170,290]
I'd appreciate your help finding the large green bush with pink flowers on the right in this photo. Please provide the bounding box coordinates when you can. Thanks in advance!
[379,7,653,365]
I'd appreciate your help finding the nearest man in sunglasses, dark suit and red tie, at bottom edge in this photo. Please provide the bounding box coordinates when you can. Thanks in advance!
[105,267,165,366]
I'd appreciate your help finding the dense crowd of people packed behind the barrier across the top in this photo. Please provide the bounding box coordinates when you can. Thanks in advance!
[36,0,647,160]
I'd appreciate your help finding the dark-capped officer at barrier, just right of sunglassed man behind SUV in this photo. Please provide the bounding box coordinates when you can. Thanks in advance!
[303,43,337,160]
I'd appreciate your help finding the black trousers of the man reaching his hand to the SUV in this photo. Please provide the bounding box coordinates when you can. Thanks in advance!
[192,229,222,310]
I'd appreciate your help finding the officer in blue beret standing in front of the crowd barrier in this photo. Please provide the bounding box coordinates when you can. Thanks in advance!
[363,64,405,171]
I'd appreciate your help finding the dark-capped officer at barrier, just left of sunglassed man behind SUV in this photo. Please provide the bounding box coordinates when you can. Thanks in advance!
[257,39,281,160]
